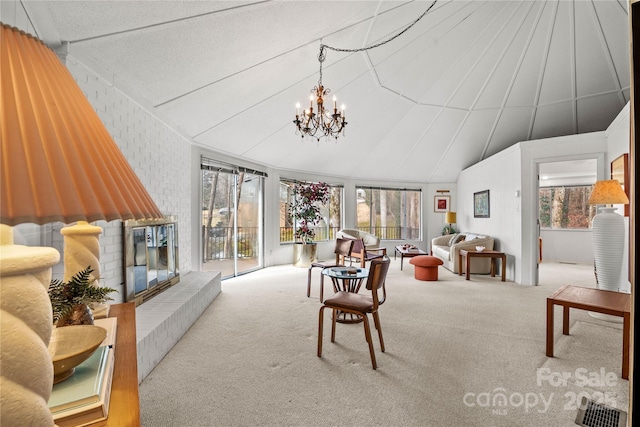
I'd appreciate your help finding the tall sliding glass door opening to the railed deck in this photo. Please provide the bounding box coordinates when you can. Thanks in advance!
[201,162,264,278]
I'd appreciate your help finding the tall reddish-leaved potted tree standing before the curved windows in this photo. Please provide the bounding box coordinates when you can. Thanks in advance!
[289,182,331,267]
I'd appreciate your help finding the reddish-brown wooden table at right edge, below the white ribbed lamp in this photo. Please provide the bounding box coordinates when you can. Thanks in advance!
[547,285,631,379]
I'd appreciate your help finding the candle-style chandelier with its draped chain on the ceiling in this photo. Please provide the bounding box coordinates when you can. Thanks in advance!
[293,0,437,141]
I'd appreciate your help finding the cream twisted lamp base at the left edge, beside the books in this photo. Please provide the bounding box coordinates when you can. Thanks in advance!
[0,224,60,427]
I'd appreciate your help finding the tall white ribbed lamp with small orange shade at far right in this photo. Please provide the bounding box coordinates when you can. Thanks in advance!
[587,179,629,291]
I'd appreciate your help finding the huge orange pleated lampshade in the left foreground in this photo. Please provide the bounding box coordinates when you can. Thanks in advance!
[0,24,162,225]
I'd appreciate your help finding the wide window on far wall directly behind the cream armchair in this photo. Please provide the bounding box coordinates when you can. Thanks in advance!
[356,186,422,240]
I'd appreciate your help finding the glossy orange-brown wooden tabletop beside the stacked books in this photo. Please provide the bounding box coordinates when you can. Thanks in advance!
[89,302,140,427]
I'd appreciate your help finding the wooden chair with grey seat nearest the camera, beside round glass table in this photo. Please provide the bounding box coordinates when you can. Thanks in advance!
[318,256,390,369]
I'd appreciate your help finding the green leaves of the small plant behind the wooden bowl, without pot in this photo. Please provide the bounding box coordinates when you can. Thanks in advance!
[49,266,116,323]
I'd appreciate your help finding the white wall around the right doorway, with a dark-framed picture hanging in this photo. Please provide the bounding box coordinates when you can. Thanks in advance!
[457,132,608,285]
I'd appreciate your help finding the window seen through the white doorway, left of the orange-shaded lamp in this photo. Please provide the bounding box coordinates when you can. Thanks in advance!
[539,185,596,229]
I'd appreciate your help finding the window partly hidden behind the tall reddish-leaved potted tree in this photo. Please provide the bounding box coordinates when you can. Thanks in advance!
[280,179,343,243]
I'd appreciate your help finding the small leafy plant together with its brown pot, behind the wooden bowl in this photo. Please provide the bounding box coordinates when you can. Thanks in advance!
[49,266,116,327]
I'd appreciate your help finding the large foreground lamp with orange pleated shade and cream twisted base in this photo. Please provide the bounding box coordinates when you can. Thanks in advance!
[0,24,162,426]
